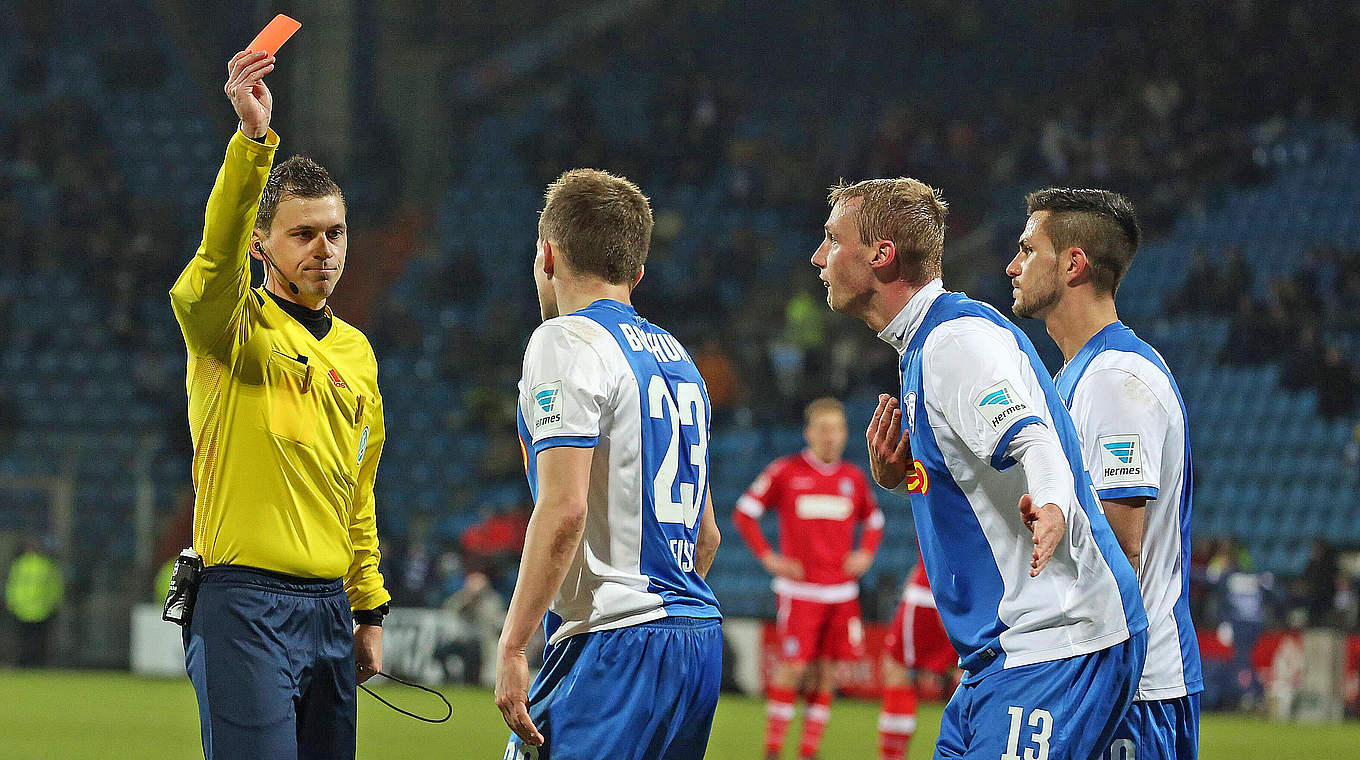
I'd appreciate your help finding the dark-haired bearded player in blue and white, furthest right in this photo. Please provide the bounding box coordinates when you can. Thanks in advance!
[1006,188,1204,760]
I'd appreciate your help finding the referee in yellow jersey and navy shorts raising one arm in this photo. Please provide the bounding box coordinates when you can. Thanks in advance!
[170,52,390,760]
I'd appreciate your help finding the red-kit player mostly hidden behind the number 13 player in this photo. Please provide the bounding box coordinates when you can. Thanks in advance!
[879,549,959,760]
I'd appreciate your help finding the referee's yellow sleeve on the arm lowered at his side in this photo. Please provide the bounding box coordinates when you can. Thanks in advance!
[344,386,392,609]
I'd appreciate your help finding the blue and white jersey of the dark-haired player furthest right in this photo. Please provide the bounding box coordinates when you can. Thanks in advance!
[1057,322,1204,700]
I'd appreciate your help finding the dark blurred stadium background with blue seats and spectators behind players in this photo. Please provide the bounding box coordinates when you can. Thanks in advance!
[0,0,1360,757]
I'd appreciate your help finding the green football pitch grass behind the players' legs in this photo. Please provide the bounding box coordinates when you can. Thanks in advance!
[0,670,1360,760]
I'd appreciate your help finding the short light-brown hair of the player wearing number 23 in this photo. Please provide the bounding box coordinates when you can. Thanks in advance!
[539,169,653,286]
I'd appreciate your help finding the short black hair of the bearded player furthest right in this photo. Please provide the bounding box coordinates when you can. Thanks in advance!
[1024,188,1142,295]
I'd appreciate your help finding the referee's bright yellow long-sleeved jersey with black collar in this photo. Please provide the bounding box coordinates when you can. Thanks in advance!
[170,131,390,609]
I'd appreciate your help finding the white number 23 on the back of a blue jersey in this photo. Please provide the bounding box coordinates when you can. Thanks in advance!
[647,375,709,530]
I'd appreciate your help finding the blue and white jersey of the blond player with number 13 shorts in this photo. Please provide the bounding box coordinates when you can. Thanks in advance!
[879,280,1146,680]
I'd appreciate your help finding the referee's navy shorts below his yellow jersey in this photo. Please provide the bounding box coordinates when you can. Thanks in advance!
[184,566,355,760]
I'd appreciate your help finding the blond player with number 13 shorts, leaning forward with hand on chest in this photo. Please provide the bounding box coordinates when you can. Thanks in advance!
[812,178,1148,760]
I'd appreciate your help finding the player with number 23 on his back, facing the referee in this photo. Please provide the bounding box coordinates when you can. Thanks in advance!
[496,170,722,760]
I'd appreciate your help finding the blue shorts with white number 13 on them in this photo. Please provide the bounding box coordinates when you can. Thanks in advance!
[934,632,1148,760]
